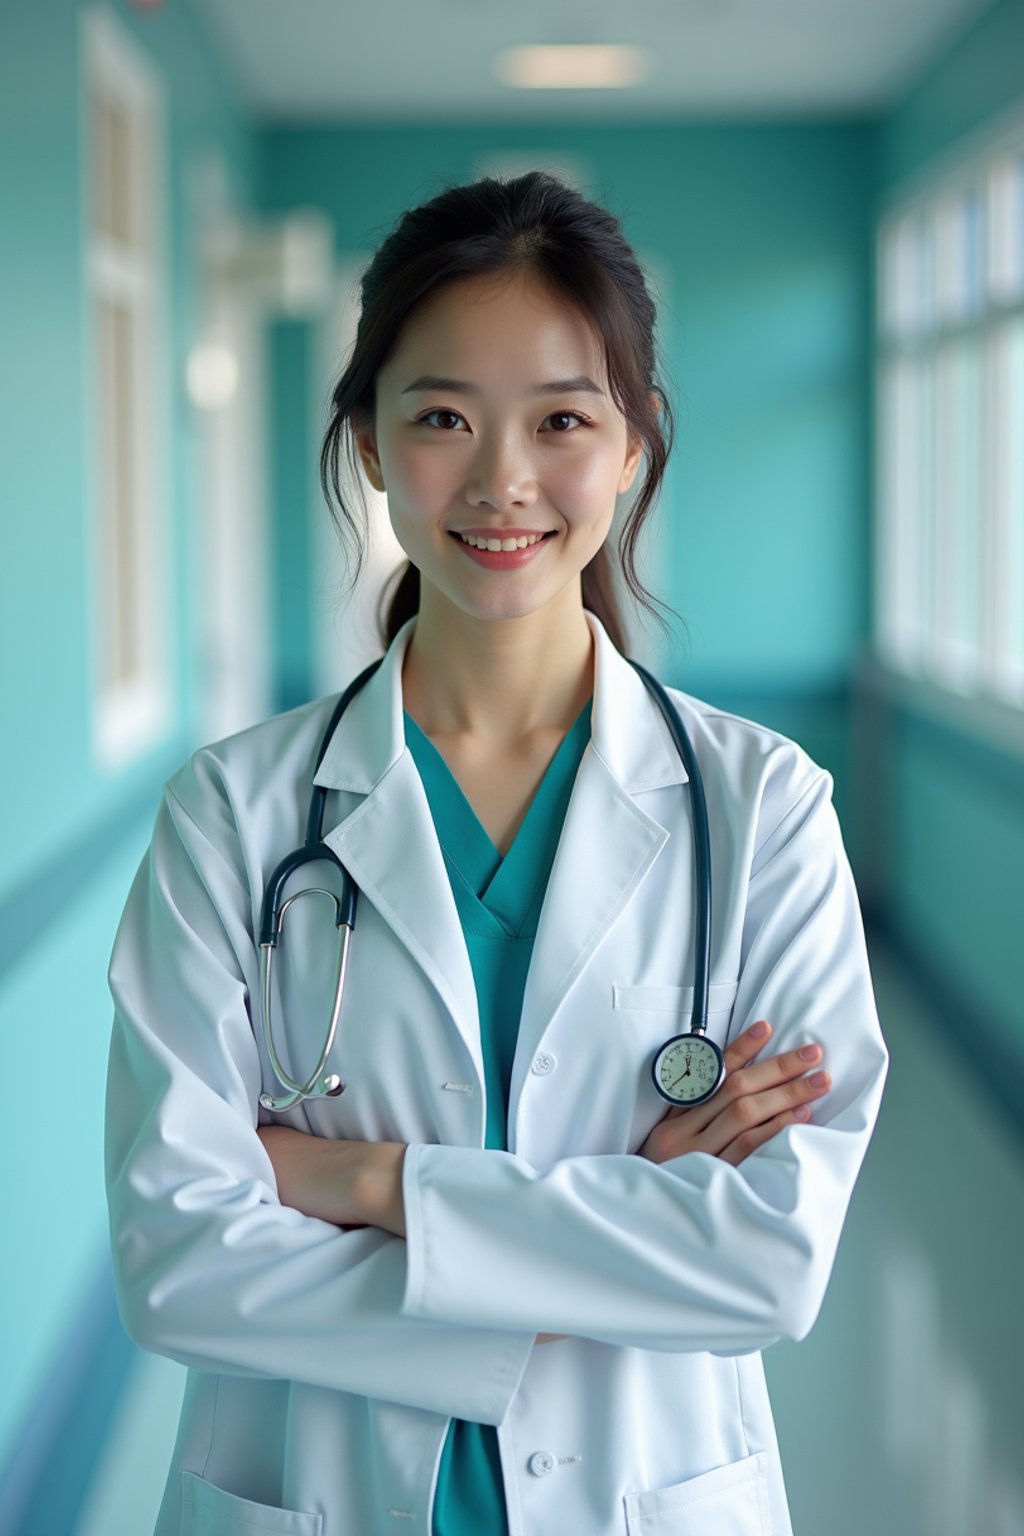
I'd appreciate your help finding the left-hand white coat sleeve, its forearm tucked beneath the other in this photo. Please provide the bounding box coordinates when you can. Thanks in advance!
[106,793,533,1424]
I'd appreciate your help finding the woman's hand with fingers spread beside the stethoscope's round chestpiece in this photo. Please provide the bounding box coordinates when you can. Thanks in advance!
[639,1018,832,1164]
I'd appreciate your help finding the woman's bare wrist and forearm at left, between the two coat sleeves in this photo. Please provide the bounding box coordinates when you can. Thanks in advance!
[256,1126,405,1238]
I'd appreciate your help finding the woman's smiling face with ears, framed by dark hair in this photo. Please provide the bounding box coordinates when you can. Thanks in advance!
[356,273,642,619]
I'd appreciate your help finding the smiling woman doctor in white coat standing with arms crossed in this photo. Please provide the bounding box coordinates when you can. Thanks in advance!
[106,172,886,1536]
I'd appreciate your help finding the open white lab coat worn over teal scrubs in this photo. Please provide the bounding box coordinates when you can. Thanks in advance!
[106,613,887,1536]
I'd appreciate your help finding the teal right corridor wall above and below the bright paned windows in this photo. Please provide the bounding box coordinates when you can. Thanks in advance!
[866,0,1024,1069]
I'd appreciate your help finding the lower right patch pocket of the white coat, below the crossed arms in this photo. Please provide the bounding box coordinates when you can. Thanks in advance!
[625,1452,772,1536]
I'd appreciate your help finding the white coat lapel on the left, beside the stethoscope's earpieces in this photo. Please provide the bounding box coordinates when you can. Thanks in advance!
[315,619,484,1077]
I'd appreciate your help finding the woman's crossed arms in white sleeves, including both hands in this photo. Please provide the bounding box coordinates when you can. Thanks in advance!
[106,755,887,1424]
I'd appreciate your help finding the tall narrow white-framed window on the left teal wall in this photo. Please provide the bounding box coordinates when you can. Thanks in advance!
[83,8,169,766]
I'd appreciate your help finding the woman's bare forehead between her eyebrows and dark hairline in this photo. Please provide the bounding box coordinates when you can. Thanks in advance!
[381,270,605,389]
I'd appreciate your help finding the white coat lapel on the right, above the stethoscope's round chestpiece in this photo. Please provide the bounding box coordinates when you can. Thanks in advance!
[510,611,686,1114]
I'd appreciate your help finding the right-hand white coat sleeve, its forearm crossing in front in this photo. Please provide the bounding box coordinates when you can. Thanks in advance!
[404,770,887,1355]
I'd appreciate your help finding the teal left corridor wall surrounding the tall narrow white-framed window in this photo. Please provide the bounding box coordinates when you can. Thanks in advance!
[0,0,258,1480]
